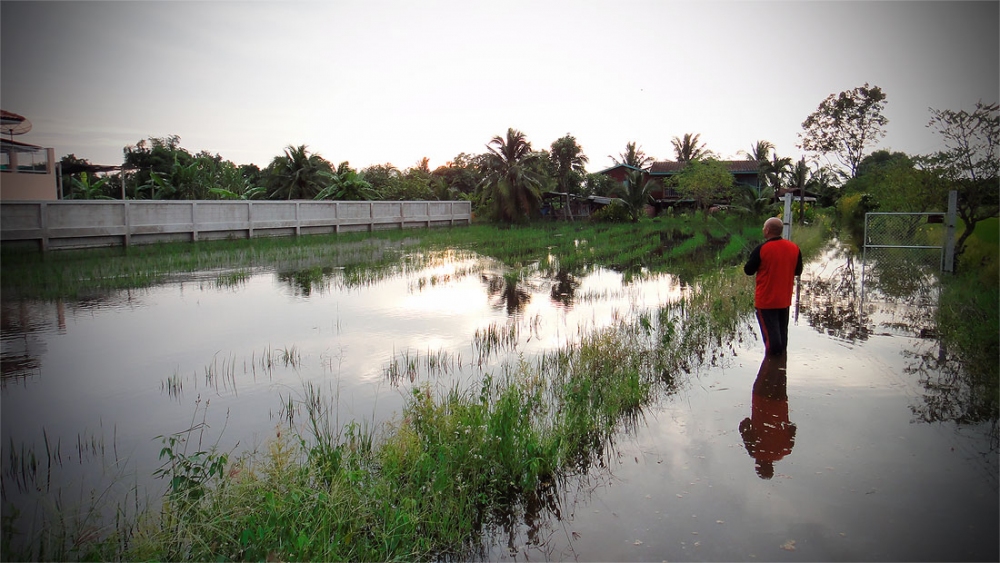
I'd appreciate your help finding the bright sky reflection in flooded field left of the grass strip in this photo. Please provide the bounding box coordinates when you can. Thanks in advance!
[3,254,679,498]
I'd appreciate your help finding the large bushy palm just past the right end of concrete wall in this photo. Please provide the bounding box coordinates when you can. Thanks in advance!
[480,128,542,223]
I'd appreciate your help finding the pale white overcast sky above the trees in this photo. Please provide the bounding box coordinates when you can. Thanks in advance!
[0,0,1000,172]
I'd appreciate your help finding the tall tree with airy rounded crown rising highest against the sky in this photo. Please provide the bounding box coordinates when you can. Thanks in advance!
[799,82,889,178]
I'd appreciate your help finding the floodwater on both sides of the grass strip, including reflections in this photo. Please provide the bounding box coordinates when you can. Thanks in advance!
[0,240,1000,561]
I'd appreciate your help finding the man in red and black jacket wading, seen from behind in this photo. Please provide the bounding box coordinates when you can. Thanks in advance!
[743,217,802,355]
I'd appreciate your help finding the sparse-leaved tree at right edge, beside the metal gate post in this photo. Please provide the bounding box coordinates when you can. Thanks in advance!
[921,100,1000,260]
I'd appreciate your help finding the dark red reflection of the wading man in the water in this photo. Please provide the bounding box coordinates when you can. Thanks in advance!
[740,354,795,479]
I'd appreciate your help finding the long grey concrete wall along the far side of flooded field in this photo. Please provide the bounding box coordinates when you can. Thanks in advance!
[0,200,472,250]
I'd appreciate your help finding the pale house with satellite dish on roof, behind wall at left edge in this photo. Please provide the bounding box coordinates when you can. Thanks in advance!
[0,110,59,201]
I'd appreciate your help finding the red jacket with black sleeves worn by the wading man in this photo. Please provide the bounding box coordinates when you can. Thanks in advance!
[743,237,802,309]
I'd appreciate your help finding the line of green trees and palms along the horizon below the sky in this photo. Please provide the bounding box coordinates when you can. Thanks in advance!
[62,83,1000,256]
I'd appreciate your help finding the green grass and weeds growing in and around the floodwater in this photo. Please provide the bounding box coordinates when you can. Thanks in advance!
[2,212,997,561]
